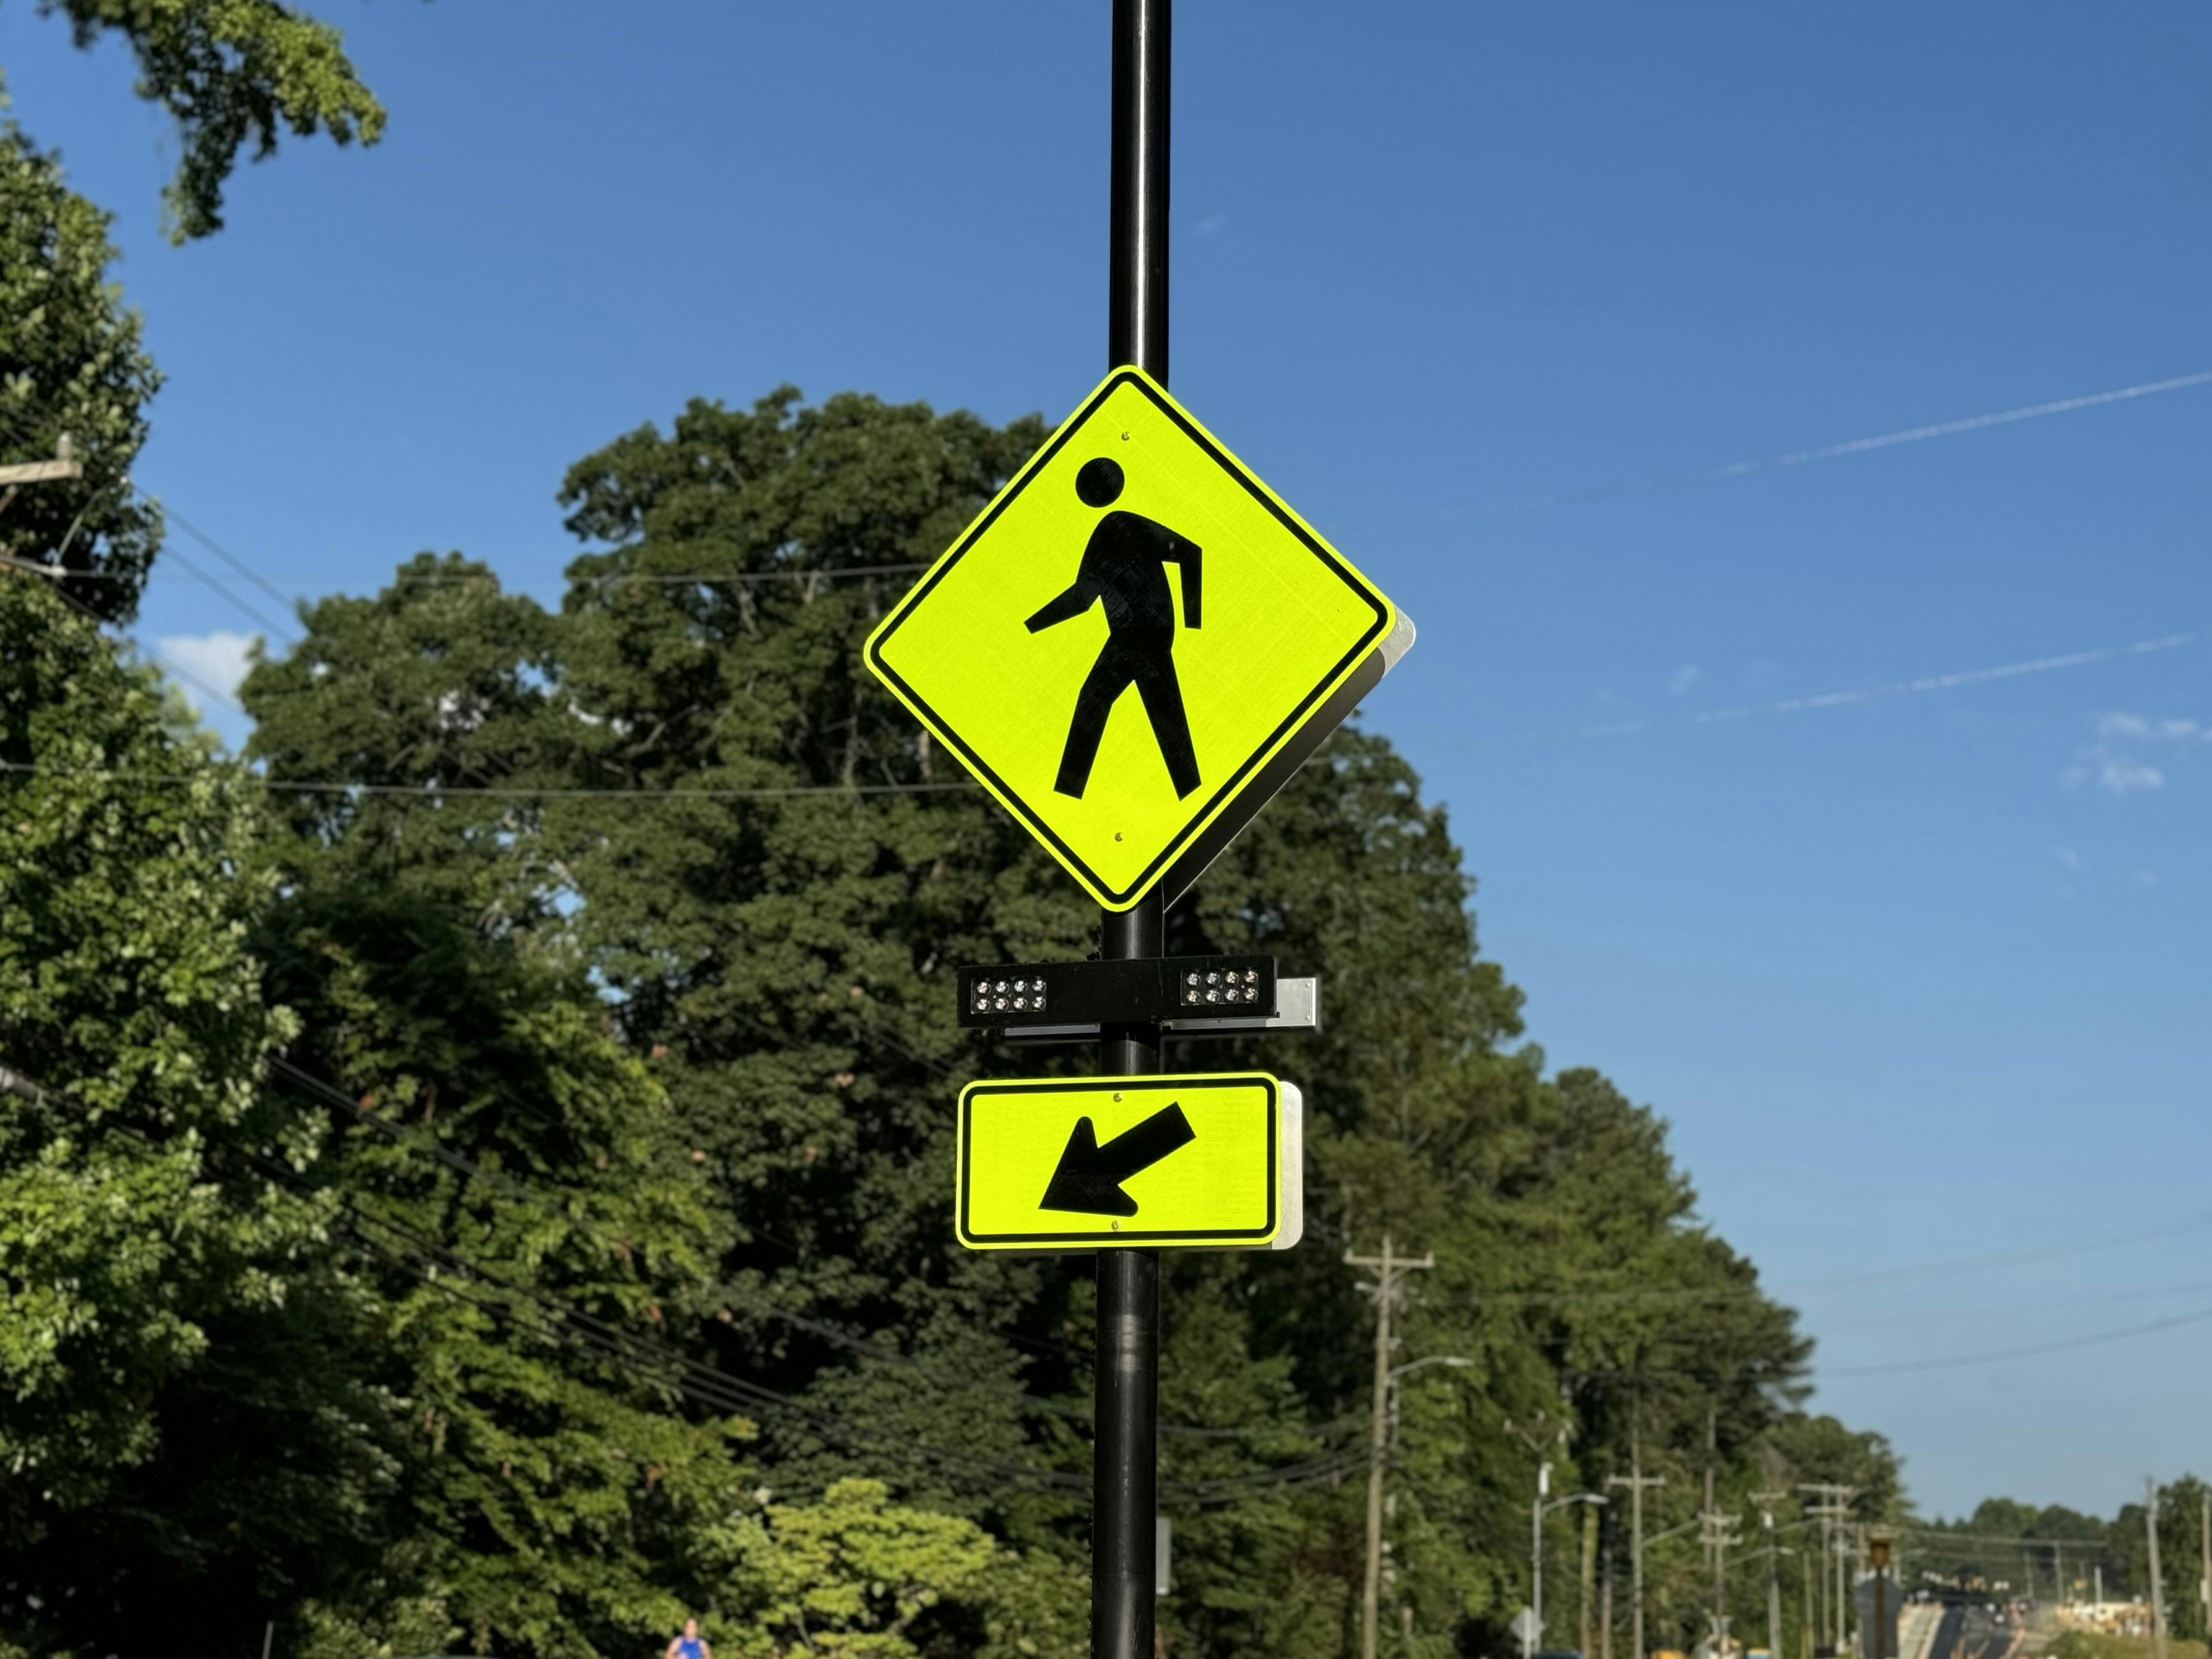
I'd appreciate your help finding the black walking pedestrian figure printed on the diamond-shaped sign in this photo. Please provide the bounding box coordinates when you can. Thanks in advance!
[1028,456,1199,801]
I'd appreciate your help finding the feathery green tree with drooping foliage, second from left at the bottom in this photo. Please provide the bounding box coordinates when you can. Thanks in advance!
[257,883,752,1654]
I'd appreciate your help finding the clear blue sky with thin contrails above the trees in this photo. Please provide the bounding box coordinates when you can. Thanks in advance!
[0,0,2212,1511]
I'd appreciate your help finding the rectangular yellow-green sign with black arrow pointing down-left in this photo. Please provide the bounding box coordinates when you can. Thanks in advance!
[956,1073,1285,1250]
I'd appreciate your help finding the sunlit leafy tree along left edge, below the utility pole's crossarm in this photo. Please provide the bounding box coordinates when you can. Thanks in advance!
[0,577,389,1652]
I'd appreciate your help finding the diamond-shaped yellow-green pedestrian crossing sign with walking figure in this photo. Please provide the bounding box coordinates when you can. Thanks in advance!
[867,367,1398,909]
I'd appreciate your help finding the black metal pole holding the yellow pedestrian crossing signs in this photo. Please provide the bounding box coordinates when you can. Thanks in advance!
[1091,0,1170,1659]
